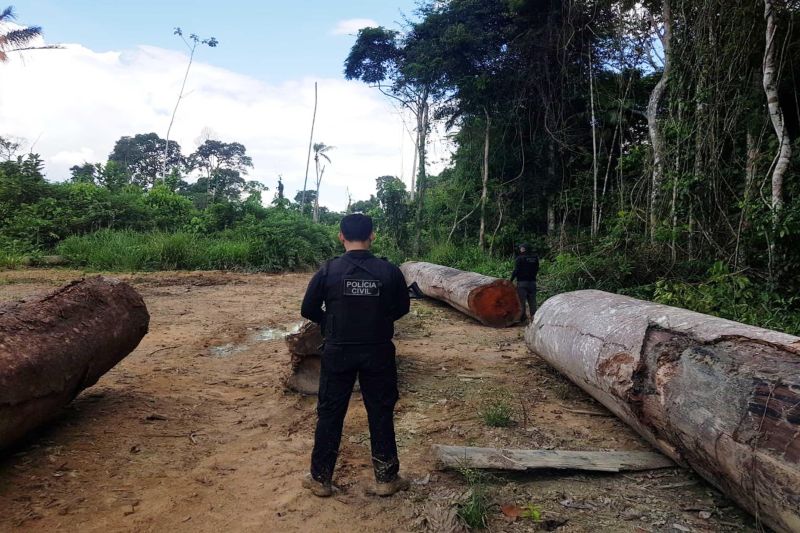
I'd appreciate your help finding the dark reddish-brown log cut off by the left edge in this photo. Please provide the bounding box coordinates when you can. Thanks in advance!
[0,277,150,449]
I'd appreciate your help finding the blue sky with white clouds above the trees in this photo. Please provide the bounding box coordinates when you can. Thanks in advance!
[0,0,449,210]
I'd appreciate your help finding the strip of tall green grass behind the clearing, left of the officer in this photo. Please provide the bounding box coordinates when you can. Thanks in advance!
[57,228,334,272]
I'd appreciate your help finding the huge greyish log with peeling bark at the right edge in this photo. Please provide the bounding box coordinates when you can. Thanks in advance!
[525,291,800,532]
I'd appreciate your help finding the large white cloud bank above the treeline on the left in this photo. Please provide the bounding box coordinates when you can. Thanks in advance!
[0,40,449,209]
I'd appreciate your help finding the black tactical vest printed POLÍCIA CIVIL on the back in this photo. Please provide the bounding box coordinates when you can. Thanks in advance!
[323,252,394,344]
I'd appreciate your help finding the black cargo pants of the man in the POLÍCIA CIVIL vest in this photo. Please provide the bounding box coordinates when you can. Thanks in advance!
[311,342,400,483]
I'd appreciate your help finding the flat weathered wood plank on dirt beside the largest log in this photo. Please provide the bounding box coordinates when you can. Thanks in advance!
[432,444,675,472]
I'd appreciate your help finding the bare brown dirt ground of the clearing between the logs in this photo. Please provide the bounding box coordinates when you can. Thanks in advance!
[0,270,759,532]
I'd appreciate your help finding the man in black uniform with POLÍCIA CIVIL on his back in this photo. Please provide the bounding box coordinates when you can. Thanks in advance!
[300,214,410,497]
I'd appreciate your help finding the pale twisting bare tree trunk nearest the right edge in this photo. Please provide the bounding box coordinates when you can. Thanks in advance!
[763,0,792,217]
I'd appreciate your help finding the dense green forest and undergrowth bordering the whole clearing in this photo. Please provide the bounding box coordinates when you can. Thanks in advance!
[0,0,800,333]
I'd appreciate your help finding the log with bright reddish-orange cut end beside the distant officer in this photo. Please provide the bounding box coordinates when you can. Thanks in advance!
[400,261,522,328]
